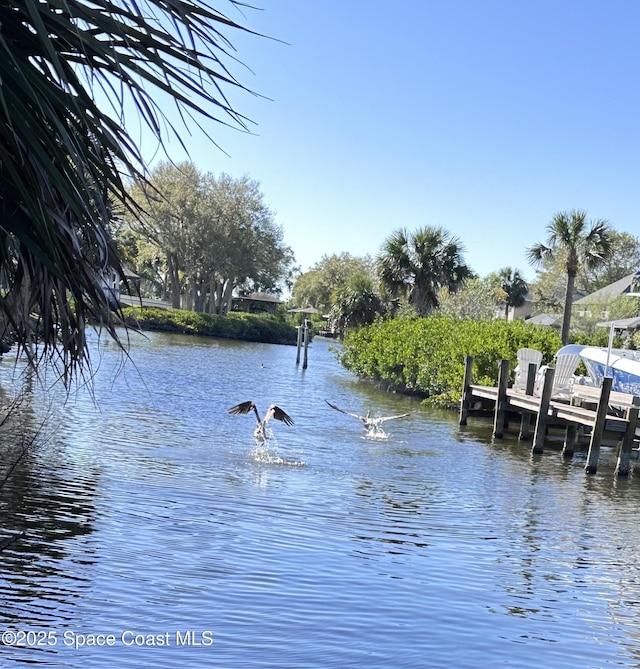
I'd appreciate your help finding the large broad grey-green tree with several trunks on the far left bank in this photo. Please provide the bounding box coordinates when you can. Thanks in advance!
[125,163,293,315]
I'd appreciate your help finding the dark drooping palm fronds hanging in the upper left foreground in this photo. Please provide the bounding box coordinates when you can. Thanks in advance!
[0,0,255,380]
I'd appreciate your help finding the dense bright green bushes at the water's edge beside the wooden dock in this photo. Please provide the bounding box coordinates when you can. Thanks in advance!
[340,316,562,407]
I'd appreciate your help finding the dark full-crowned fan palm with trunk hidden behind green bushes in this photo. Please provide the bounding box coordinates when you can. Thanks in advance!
[376,226,472,316]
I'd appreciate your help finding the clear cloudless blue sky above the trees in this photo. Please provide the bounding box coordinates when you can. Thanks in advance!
[139,0,640,279]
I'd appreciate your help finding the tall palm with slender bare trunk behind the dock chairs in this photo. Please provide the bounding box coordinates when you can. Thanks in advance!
[527,209,612,344]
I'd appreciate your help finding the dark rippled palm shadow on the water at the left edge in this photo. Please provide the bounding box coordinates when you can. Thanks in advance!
[0,375,97,626]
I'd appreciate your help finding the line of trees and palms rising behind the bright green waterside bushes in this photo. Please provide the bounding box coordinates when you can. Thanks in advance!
[293,210,640,343]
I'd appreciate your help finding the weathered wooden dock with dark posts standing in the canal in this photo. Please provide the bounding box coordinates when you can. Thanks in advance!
[459,356,640,476]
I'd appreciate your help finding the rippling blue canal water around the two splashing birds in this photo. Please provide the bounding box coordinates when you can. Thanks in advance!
[0,333,640,669]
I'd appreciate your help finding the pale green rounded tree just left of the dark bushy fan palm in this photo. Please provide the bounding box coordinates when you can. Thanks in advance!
[292,253,372,313]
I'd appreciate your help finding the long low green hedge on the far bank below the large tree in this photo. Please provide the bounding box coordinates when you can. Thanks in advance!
[124,307,297,344]
